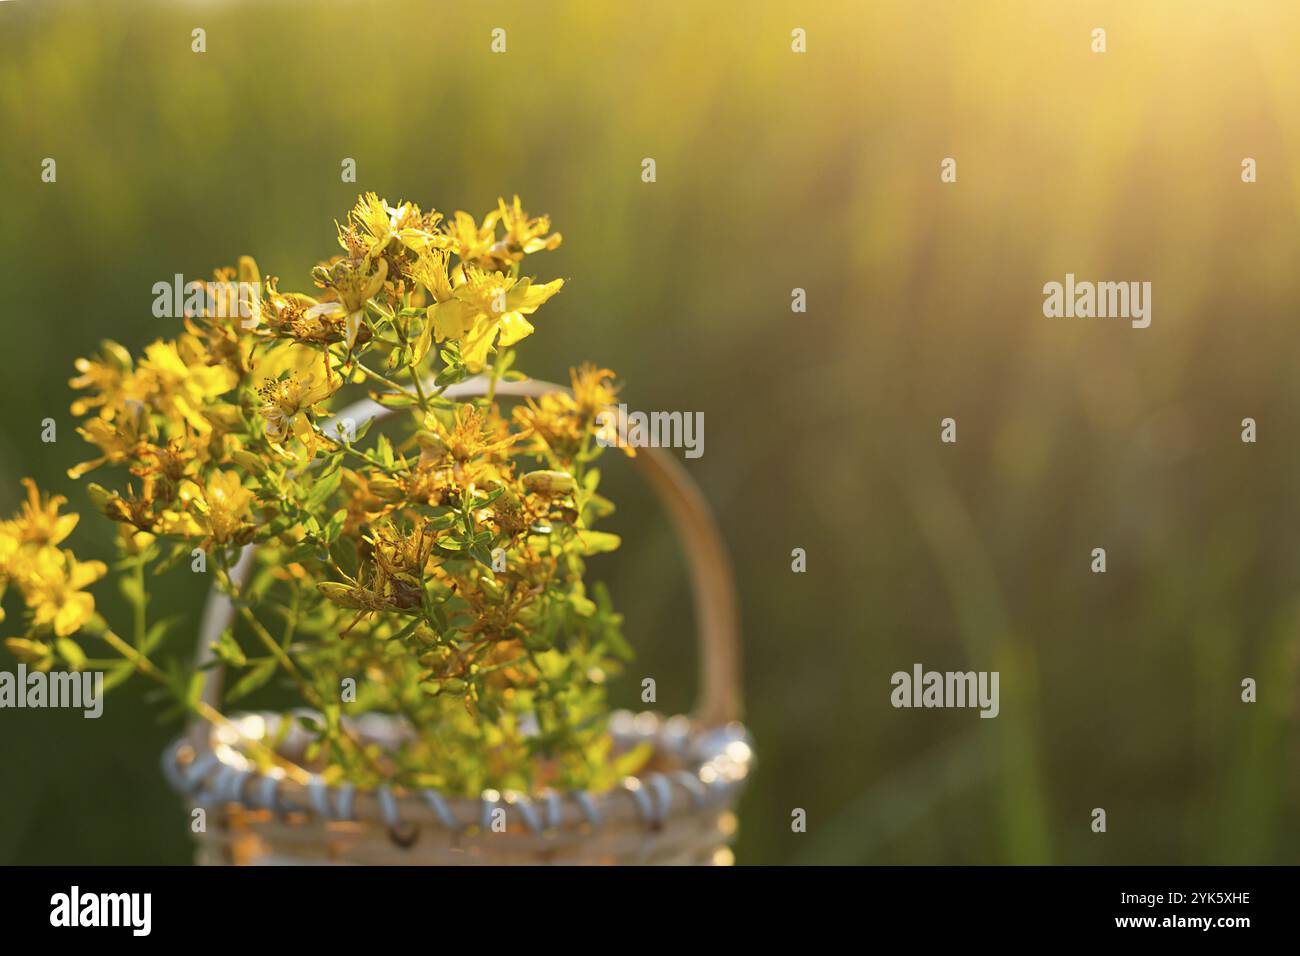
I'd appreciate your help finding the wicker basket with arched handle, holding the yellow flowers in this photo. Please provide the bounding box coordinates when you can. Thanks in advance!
[163,380,751,865]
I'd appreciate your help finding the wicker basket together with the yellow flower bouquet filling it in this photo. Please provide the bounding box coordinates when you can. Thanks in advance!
[0,194,750,864]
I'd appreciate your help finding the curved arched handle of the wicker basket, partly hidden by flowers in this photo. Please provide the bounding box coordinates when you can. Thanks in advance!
[196,376,741,728]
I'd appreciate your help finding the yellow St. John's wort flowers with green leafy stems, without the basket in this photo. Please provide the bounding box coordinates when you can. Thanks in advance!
[0,194,642,793]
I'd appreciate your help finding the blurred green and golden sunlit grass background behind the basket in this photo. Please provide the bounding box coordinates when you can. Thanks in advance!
[0,0,1300,864]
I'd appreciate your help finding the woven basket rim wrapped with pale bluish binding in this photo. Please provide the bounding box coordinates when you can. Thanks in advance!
[163,710,753,834]
